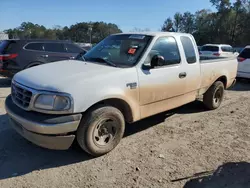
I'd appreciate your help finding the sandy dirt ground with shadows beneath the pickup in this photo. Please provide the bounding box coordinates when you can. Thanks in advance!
[0,79,250,188]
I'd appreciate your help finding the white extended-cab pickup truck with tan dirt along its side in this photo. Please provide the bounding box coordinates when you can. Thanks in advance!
[5,32,238,156]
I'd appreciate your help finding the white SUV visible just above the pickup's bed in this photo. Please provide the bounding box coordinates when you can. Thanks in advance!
[200,44,237,57]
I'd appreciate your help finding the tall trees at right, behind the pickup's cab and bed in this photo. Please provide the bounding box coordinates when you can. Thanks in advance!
[162,0,250,46]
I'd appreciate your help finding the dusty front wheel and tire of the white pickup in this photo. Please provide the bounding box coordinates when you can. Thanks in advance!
[76,105,125,156]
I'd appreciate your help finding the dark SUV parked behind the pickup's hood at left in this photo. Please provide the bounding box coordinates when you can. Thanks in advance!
[0,40,86,77]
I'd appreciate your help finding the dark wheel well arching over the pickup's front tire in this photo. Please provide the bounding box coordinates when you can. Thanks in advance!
[88,98,133,123]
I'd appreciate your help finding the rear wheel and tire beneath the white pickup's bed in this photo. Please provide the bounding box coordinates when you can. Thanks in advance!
[203,81,224,110]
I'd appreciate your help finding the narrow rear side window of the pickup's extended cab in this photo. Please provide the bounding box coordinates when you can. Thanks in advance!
[181,36,197,64]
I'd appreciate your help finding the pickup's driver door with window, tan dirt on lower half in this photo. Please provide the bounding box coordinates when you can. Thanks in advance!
[138,37,186,118]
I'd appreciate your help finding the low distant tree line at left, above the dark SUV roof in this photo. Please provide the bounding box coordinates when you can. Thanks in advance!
[5,22,122,43]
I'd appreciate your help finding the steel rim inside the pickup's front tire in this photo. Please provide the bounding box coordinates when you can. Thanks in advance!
[94,119,117,146]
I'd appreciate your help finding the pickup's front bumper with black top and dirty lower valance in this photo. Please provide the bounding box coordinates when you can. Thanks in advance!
[5,96,82,150]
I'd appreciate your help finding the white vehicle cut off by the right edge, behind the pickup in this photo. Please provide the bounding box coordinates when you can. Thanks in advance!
[237,46,250,78]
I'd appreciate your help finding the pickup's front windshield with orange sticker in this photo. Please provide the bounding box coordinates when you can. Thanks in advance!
[76,34,152,66]
